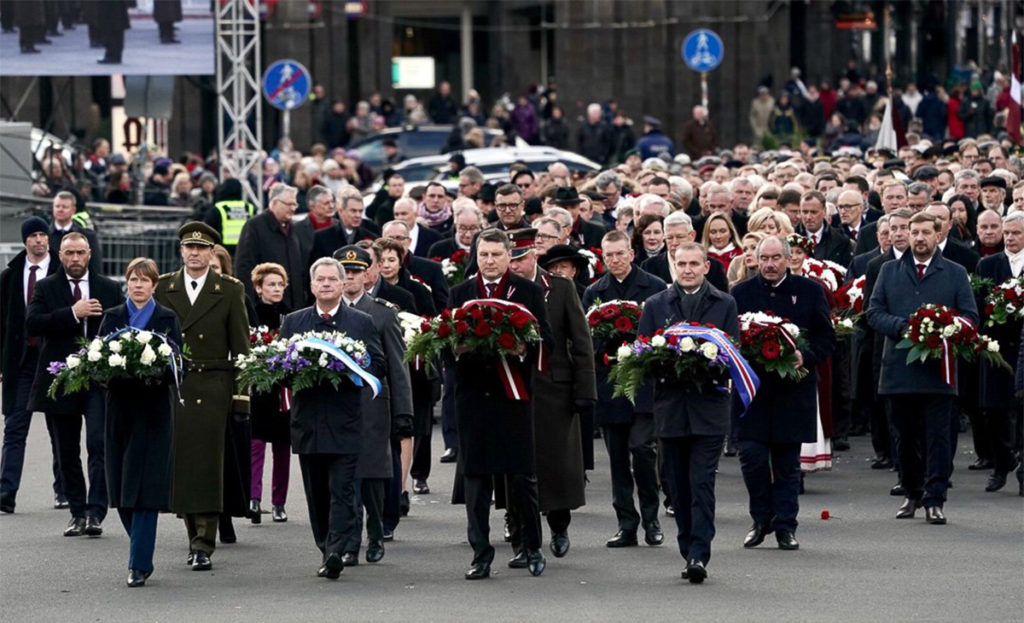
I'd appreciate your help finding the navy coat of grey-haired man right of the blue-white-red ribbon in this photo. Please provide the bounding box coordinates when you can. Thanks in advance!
[732,275,836,444]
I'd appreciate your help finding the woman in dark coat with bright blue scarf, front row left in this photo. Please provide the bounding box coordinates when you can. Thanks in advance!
[99,257,181,587]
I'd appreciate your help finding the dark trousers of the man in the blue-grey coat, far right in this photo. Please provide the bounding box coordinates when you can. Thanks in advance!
[889,393,953,507]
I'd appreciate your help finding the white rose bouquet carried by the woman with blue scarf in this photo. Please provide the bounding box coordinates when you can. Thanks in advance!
[46,328,182,399]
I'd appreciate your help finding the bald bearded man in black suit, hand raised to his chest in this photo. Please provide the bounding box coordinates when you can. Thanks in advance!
[26,232,122,536]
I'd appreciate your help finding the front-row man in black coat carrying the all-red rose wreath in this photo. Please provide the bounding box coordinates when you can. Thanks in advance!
[449,230,553,580]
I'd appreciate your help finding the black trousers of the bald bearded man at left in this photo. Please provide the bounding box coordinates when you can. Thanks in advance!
[46,389,108,522]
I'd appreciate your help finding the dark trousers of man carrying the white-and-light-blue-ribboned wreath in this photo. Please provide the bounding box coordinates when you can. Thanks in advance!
[299,454,360,556]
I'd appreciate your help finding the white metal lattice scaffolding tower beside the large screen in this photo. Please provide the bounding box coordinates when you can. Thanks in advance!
[217,0,263,210]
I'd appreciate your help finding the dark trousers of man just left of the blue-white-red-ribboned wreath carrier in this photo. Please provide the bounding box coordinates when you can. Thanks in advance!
[601,414,658,532]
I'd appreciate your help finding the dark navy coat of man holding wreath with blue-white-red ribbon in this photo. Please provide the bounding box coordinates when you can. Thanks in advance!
[638,284,739,438]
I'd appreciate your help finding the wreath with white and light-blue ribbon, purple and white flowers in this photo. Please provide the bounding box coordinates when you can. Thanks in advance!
[234,331,380,396]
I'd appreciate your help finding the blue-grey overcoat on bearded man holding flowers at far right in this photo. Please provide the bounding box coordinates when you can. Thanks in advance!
[867,251,978,396]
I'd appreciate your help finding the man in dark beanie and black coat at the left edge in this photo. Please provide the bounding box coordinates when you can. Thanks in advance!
[0,216,63,512]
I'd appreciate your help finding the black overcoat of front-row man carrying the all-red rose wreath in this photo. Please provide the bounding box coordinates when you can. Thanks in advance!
[450,274,554,476]
